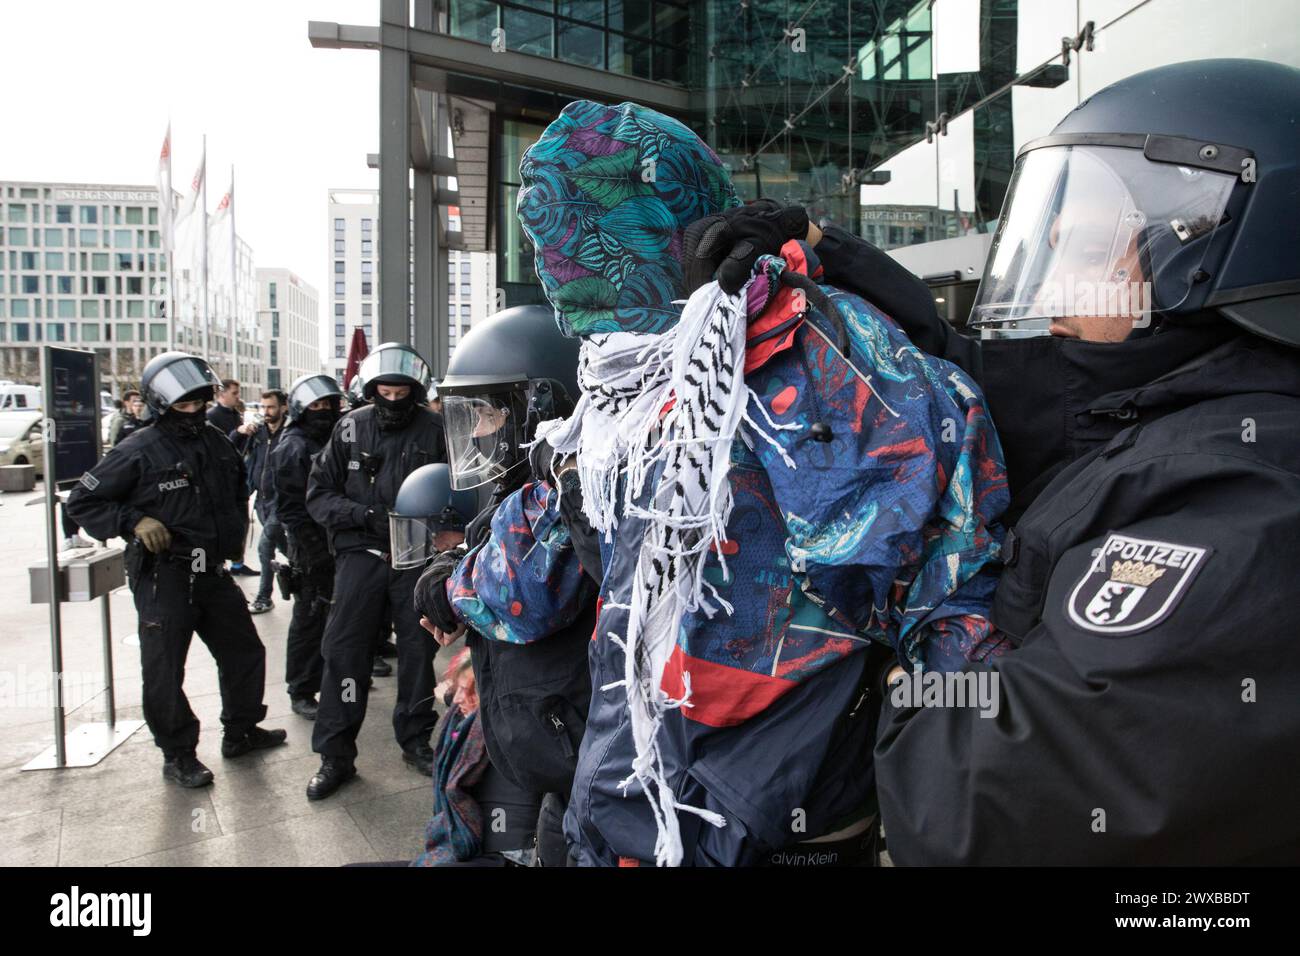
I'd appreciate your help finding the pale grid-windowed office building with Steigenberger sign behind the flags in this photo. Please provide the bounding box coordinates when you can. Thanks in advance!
[0,182,264,394]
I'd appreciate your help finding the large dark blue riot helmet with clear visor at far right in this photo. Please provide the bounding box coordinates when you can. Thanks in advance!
[971,60,1300,345]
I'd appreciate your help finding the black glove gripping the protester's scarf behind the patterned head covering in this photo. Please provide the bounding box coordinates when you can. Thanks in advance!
[681,199,809,295]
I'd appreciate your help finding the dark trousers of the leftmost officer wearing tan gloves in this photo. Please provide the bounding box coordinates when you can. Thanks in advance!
[131,561,267,757]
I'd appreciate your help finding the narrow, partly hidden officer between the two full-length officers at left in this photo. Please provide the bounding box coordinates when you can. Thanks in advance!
[267,375,343,721]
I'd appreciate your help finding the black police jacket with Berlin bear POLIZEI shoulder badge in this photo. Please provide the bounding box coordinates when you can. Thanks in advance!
[876,334,1300,864]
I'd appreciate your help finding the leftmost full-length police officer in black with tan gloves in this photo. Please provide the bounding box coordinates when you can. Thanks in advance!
[68,351,287,787]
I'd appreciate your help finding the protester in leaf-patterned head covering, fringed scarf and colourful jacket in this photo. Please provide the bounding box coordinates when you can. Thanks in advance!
[436,101,1006,865]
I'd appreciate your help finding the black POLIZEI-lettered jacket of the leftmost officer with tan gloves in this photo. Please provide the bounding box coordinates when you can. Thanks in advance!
[68,423,248,561]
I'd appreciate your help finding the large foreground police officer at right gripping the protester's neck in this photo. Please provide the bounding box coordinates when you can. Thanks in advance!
[688,60,1300,865]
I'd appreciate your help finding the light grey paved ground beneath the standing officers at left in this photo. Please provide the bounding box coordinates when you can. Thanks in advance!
[0,485,450,866]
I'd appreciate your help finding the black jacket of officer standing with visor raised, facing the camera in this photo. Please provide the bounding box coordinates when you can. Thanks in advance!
[307,406,447,554]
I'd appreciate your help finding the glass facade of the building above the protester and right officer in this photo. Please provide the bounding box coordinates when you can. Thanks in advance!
[451,0,1300,321]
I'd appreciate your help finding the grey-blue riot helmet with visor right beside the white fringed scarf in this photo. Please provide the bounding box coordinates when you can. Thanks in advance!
[438,306,579,489]
